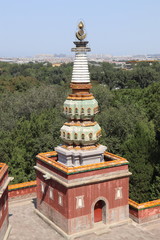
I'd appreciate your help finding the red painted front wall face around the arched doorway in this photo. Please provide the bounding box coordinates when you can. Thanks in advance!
[67,177,128,218]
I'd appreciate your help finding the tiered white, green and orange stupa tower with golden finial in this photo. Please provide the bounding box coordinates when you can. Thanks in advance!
[56,22,106,165]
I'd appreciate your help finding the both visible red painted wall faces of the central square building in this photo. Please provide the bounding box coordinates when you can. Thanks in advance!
[37,171,129,218]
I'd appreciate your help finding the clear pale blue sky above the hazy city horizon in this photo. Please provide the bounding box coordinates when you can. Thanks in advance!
[0,0,160,57]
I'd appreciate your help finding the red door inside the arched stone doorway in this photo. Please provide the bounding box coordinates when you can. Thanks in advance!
[94,200,106,223]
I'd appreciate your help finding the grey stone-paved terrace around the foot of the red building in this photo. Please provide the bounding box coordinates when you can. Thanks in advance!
[9,199,160,240]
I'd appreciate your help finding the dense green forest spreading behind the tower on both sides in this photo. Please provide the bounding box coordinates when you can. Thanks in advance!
[0,62,160,202]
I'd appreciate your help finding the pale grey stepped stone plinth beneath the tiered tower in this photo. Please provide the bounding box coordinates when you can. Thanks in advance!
[55,145,107,167]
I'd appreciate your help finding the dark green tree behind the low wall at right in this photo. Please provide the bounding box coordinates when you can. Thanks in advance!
[122,121,156,202]
